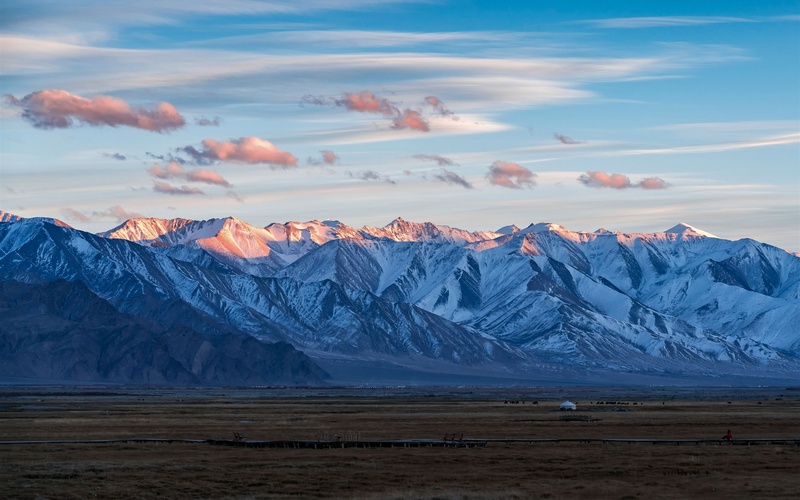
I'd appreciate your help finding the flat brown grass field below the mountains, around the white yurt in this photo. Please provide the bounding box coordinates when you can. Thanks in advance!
[0,387,800,499]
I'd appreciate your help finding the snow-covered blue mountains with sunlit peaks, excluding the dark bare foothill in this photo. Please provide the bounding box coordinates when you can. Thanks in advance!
[0,210,800,380]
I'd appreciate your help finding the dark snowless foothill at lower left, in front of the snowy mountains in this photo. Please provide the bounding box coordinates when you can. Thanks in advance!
[0,280,327,385]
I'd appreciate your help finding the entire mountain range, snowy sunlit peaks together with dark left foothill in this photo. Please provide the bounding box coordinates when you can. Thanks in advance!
[0,212,800,385]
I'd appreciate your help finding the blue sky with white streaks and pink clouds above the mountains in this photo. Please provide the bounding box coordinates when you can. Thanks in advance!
[0,0,800,252]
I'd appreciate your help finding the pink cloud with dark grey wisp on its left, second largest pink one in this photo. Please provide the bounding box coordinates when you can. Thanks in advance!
[180,137,297,168]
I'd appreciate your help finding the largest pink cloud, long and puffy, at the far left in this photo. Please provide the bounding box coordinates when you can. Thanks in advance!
[6,90,186,132]
